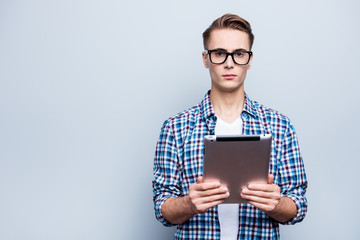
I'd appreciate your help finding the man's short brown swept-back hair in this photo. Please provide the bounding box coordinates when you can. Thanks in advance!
[203,14,254,49]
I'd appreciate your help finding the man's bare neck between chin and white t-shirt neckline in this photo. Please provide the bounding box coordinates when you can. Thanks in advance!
[210,87,245,123]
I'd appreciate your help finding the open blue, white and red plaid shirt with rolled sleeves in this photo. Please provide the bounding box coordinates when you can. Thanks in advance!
[153,92,307,240]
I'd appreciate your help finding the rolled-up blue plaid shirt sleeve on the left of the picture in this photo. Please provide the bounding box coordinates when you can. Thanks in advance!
[152,121,181,227]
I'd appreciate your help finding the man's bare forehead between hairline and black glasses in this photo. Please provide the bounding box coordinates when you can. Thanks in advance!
[208,29,250,51]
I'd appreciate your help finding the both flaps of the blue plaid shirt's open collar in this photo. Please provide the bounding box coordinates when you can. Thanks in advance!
[200,90,258,119]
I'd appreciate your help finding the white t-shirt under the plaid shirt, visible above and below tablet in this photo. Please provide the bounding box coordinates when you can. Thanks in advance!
[215,116,242,240]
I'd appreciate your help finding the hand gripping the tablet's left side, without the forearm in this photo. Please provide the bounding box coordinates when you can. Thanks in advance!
[188,177,230,214]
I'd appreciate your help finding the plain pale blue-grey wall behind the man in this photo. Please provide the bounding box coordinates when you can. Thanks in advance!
[0,0,360,240]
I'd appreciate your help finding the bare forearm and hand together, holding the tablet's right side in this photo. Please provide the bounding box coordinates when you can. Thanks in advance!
[240,174,297,222]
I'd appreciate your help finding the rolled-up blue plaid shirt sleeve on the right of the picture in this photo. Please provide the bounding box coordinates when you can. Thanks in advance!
[279,123,308,225]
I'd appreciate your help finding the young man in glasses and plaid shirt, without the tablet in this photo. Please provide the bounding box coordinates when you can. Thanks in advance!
[153,14,307,239]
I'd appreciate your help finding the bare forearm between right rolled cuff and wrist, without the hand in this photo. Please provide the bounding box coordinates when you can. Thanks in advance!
[266,197,297,223]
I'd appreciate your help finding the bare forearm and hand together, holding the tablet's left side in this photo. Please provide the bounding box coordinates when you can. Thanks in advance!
[161,177,230,224]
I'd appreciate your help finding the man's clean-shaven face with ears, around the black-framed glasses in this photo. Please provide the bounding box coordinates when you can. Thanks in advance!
[203,29,252,92]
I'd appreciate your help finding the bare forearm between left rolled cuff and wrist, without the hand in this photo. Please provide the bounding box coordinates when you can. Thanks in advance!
[161,196,196,224]
